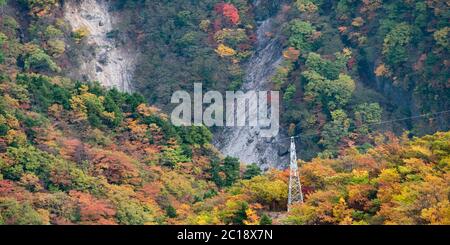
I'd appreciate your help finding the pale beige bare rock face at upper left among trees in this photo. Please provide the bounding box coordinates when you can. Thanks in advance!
[64,0,137,92]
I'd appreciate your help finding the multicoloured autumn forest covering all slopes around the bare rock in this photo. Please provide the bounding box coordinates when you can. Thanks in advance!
[0,0,450,225]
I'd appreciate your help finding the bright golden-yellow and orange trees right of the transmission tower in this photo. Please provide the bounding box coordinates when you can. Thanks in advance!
[284,132,450,224]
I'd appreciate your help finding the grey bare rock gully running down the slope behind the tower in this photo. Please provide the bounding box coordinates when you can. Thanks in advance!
[215,19,289,169]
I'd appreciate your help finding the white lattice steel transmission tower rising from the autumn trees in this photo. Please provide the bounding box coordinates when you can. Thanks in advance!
[288,137,303,211]
